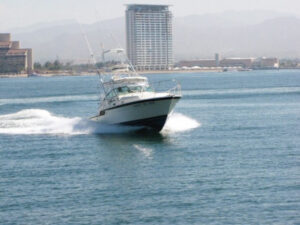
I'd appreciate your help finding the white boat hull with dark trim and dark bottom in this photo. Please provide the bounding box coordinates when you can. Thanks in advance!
[91,96,180,131]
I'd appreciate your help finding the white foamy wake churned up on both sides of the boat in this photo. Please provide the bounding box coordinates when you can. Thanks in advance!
[0,109,200,135]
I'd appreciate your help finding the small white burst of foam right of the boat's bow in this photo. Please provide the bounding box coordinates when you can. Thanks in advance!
[163,113,201,132]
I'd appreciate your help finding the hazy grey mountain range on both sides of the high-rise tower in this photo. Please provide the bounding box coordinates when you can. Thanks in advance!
[11,11,300,62]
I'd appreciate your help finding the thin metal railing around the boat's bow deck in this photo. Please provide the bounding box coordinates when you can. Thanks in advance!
[149,79,181,96]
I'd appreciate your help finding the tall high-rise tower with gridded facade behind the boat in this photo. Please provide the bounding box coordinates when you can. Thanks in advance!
[126,4,173,70]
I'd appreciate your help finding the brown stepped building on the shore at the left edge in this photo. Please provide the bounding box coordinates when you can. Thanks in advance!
[0,33,33,73]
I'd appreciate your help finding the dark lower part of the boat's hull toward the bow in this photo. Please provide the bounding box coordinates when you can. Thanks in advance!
[121,115,168,132]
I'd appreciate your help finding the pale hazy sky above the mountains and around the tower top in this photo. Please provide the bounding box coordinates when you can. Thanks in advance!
[0,0,300,31]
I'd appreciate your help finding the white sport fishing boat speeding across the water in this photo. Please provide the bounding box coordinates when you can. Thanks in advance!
[91,48,181,132]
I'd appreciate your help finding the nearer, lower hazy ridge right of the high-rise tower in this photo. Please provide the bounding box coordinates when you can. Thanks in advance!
[174,17,300,58]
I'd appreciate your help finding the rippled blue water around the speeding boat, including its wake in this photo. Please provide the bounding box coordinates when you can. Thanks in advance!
[0,70,300,224]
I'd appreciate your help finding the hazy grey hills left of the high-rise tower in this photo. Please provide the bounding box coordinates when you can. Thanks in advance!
[12,18,125,62]
